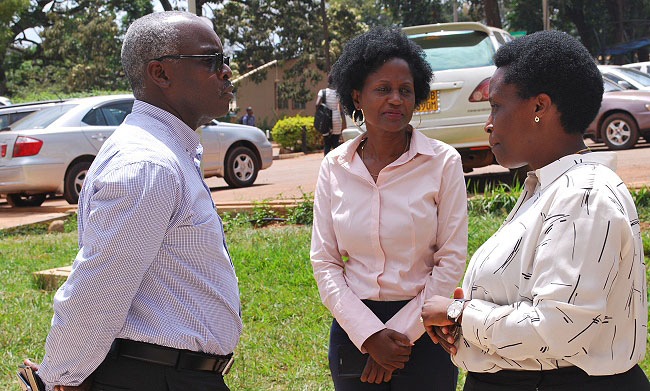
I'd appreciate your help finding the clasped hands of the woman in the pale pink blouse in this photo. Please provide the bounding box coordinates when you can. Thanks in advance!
[363,329,411,372]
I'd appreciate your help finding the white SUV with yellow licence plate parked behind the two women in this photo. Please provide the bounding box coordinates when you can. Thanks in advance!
[343,22,513,172]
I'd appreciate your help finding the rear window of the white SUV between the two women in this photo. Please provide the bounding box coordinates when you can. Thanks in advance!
[409,31,494,71]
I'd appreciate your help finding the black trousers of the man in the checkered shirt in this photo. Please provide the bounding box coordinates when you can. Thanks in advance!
[91,354,229,391]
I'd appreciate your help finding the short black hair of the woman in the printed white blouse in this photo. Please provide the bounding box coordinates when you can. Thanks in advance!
[494,30,603,134]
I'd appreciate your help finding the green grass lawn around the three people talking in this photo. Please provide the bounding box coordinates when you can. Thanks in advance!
[0,207,650,391]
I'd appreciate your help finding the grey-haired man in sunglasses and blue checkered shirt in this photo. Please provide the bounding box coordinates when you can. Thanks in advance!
[26,11,242,391]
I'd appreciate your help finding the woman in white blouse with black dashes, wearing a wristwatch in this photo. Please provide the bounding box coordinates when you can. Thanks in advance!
[422,31,650,391]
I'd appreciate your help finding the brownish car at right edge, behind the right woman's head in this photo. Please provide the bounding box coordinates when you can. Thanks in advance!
[585,78,650,149]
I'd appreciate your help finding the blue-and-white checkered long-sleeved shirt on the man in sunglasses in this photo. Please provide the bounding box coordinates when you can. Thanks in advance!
[38,100,242,389]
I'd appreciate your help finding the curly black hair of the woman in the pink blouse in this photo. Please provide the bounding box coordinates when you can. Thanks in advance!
[330,27,432,121]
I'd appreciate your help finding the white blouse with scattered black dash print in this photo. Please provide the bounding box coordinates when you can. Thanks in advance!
[453,152,648,375]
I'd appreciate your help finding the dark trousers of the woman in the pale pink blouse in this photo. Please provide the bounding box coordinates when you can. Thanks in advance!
[328,300,458,391]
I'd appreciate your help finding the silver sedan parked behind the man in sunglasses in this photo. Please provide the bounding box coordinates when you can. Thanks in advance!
[0,95,273,206]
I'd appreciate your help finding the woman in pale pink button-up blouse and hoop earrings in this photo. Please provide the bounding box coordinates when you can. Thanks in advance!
[311,28,467,391]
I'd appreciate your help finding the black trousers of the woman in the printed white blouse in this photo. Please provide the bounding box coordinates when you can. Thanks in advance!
[463,365,650,391]
